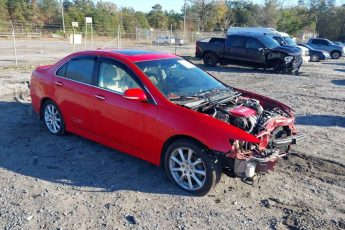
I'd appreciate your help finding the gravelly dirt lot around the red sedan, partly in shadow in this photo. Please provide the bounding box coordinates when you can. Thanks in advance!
[0,40,345,229]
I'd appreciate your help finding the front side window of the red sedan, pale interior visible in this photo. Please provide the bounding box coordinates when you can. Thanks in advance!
[98,61,140,93]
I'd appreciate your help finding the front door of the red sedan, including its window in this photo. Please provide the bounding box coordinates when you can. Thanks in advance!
[91,58,157,157]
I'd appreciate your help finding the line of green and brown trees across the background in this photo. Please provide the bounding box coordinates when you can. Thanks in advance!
[0,0,345,40]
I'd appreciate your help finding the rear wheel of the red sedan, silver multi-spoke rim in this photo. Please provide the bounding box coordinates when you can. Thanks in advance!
[42,100,66,136]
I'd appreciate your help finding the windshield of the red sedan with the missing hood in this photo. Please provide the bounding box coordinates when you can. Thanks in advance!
[136,58,230,99]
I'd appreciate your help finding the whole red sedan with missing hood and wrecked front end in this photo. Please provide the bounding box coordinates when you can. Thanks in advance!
[30,50,305,195]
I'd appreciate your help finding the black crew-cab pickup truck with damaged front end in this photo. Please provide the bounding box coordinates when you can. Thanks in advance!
[195,34,303,74]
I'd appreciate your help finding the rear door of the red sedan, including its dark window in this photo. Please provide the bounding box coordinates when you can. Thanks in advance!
[53,56,96,131]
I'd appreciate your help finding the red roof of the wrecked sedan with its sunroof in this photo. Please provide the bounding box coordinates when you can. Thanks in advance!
[84,49,179,62]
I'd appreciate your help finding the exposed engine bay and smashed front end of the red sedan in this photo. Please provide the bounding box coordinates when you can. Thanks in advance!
[176,90,305,181]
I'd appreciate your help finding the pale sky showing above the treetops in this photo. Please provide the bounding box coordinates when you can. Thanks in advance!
[108,0,345,12]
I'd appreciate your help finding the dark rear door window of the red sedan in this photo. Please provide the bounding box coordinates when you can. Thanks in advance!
[65,58,95,84]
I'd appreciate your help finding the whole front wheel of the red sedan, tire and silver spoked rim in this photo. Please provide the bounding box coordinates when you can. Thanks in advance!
[164,140,221,196]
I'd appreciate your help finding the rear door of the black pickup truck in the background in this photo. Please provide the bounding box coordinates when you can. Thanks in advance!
[224,35,246,61]
